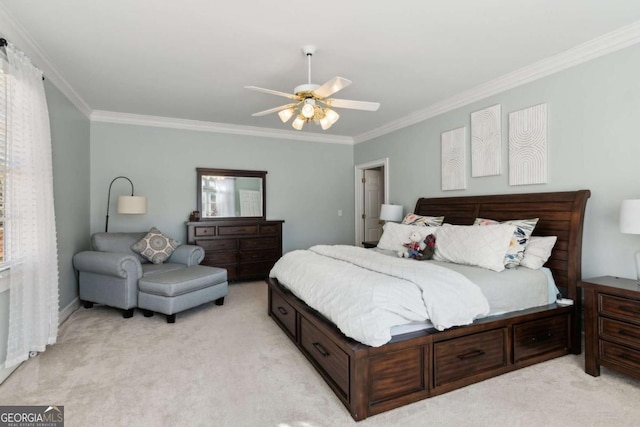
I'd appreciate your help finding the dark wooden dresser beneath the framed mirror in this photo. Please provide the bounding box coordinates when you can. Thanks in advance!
[187,219,284,281]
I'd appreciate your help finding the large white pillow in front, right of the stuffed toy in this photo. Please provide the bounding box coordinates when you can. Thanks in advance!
[433,224,516,271]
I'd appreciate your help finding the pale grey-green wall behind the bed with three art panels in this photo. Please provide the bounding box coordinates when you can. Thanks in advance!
[354,45,640,278]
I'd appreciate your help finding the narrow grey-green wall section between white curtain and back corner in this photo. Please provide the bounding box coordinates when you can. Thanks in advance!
[45,80,91,310]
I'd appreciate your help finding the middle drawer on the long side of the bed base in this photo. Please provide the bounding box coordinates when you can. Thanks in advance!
[433,329,507,387]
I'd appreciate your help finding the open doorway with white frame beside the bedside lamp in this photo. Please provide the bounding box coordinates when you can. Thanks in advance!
[355,158,389,246]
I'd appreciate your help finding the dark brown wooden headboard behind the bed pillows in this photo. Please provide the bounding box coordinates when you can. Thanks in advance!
[415,190,591,300]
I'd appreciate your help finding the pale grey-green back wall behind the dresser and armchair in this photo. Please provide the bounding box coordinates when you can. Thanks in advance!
[91,122,354,252]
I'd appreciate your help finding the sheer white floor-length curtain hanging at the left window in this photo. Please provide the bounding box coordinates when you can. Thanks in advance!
[4,44,58,368]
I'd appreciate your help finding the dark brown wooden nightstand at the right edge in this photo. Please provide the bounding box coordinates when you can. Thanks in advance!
[578,276,640,379]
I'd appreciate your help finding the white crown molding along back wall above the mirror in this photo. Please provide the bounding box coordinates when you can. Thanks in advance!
[90,110,353,145]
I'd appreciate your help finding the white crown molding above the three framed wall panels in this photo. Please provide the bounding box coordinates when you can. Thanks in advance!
[353,21,640,144]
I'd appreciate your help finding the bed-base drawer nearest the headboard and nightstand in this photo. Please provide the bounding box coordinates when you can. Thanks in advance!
[513,316,569,363]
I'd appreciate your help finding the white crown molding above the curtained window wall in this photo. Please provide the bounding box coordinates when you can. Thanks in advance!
[0,4,91,117]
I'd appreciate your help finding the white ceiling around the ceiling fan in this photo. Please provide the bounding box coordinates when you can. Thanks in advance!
[0,0,640,141]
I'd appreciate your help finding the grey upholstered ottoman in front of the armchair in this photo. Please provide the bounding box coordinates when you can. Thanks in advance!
[138,265,228,323]
